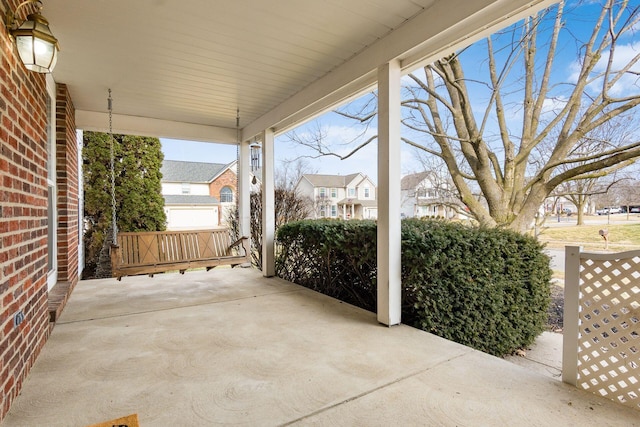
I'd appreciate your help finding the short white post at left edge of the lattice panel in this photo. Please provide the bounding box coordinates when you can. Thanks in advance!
[562,246,582,386]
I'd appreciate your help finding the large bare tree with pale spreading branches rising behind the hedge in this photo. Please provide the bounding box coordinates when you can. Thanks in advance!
[288,0,640,231]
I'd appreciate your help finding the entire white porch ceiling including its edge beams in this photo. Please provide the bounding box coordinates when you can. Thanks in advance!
[42,0,553,143]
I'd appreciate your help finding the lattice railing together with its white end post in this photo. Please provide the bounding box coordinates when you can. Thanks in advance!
[562,246,640,410]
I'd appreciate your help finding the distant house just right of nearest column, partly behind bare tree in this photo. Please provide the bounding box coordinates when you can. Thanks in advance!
[400,172,467,219]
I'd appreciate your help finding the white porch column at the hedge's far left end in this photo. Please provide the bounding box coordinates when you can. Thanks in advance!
[262,129,276,277]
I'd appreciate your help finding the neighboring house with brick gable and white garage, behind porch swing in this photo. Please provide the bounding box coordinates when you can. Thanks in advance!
[161,160,237,230]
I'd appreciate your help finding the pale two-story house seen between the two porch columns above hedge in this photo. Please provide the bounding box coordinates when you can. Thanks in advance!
[296,173,378,219]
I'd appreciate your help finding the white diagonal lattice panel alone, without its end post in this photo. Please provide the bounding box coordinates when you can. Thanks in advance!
[577,251,640,409]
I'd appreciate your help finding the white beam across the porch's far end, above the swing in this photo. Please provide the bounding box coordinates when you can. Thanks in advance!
[76,110,238,144]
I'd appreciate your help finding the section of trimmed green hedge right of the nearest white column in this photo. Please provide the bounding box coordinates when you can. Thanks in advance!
[402,220,551,356]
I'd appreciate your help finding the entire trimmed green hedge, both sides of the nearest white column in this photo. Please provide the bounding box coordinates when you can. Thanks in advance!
[277,219,551,356]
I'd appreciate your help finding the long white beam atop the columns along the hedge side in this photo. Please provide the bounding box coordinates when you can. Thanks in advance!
[242,0,557,140]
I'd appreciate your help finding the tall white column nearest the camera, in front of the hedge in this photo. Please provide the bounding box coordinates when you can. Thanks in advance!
[378,61,402,326]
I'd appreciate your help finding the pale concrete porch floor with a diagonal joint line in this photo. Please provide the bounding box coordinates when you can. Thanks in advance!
[2,269,640,427]
